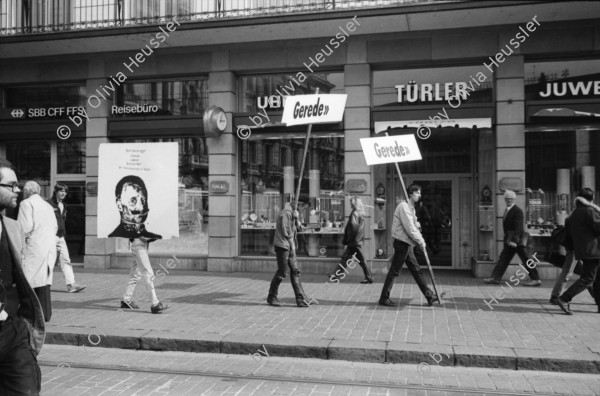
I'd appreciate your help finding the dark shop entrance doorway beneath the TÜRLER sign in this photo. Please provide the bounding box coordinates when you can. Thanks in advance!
[406,174,472,269]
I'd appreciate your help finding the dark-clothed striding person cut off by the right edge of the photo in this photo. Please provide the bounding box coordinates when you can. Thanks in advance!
[556,188,600,315]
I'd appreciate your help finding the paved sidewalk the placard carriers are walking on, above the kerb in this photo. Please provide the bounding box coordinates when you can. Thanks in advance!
[47,269,600,372]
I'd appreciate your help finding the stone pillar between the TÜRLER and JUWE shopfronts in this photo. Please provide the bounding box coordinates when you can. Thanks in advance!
[494,51,527,260]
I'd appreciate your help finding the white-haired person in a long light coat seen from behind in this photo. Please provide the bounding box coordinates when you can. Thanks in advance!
[18,181,58,322]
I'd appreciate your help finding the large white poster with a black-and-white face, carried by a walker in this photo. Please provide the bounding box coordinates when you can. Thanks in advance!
[98,142,179,239]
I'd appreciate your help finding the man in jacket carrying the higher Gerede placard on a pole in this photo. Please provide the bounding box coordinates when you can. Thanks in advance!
[267,202,310,308]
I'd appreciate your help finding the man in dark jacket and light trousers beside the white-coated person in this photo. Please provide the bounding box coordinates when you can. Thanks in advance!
[47,183,85,293]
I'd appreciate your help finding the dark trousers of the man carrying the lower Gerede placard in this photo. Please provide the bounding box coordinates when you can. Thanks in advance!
[379,239,435,301]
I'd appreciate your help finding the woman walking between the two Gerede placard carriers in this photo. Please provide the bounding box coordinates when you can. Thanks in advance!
[329,197,373,283]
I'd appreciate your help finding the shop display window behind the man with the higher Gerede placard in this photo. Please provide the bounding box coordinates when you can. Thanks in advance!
[240,134,346,257]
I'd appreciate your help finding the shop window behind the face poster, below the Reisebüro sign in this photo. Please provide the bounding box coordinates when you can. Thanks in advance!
[117,137,209,257]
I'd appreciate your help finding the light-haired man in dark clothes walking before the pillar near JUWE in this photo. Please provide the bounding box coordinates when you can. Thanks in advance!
[484,190,542,286]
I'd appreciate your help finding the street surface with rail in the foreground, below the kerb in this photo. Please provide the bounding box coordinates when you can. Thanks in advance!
[39,345,600,396]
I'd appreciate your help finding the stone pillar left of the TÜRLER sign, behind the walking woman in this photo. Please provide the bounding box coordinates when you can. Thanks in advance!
[344,40,375,263]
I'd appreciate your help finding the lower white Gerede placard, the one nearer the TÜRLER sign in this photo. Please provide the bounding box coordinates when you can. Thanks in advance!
[360,135,422,165]
